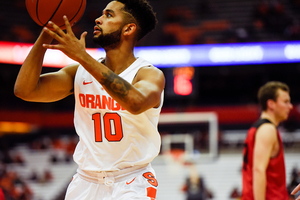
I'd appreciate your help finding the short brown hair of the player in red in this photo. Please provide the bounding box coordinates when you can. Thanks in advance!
[257,81,290,111]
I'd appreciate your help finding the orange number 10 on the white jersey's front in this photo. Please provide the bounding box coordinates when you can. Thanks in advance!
[93,113,123,142]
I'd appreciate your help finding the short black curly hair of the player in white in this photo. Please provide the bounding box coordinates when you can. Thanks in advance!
[116,0,157,40]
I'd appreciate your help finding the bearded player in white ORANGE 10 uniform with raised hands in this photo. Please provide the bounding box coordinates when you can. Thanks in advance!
[15,0,165,200]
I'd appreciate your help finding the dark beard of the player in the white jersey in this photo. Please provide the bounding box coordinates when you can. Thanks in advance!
[93,28,122,49]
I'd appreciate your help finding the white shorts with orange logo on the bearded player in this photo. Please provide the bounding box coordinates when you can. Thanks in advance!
[65,164,158,200]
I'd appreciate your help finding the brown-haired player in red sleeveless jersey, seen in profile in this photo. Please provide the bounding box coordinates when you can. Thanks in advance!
[242,81,293,200]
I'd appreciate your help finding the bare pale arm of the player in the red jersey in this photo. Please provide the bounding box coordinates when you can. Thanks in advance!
[253,124,277,200]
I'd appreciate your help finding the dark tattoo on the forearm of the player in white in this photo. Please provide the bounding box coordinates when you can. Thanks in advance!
[101,71,131,100]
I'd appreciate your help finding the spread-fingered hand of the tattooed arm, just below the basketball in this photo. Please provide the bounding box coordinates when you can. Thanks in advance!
[43,16,87,62]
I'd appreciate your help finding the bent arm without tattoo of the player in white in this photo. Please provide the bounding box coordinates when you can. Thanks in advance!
[14,31,78,102]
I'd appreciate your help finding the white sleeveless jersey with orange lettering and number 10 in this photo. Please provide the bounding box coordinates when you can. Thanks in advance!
[73,58,163,171]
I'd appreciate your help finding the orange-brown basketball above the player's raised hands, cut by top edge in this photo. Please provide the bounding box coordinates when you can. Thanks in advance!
[26,0,86,29]
